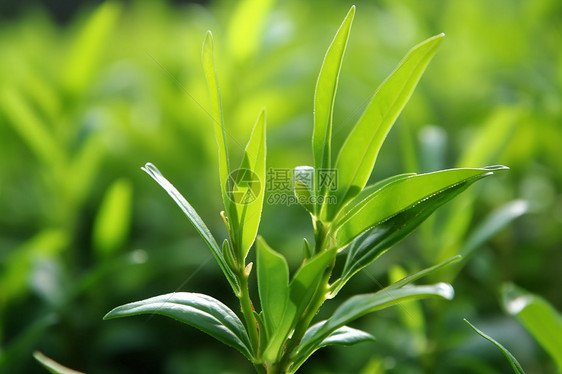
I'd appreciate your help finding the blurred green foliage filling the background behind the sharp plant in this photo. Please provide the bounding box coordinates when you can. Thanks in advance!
[0,0,562,373]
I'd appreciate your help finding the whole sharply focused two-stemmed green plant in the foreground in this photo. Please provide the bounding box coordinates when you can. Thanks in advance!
[105,7,506,373]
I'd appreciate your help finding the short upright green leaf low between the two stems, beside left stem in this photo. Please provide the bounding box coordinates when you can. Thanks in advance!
[257,237,289,336]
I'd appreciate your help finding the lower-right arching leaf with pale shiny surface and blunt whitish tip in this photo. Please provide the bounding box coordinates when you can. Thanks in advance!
[296,283,454,368]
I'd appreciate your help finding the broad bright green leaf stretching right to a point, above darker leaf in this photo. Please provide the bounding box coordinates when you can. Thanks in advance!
[333,166,507,247]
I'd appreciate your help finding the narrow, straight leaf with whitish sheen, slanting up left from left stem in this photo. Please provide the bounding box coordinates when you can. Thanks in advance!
[141,163,240,294]
